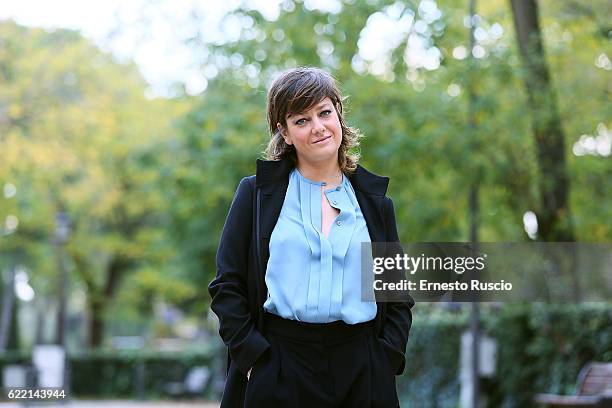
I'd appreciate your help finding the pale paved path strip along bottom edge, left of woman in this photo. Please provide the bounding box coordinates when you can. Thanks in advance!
[0,400,219,408]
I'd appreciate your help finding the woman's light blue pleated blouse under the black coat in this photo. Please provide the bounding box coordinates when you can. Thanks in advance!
[264,168,376,324]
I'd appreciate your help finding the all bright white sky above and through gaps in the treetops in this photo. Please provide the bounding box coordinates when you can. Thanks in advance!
[0,0,442,97]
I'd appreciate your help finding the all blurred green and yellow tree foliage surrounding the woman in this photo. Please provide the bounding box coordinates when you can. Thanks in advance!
[0,0,612,354]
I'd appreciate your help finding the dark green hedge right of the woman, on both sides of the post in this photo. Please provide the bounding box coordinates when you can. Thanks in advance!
[398,303,612,407]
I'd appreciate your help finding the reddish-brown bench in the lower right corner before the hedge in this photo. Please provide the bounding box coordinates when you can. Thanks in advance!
[535,363,612,408]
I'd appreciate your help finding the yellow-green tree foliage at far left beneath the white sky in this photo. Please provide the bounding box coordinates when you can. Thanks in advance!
[0,21,186,341]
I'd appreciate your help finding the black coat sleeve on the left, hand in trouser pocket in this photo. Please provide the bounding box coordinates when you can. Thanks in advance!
[208,178,270,375]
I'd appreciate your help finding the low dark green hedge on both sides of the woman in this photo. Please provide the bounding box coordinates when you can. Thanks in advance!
[0,303,612,408]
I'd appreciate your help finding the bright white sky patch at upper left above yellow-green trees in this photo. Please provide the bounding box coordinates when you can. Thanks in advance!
[0,0,278,96]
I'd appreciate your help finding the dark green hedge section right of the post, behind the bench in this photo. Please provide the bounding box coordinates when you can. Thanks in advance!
[487,303,612,407]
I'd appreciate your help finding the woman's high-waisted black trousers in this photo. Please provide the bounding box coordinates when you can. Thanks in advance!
[245,314,399,408]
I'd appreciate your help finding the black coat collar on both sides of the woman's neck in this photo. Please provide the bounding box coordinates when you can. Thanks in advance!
[255,157,389,196]
